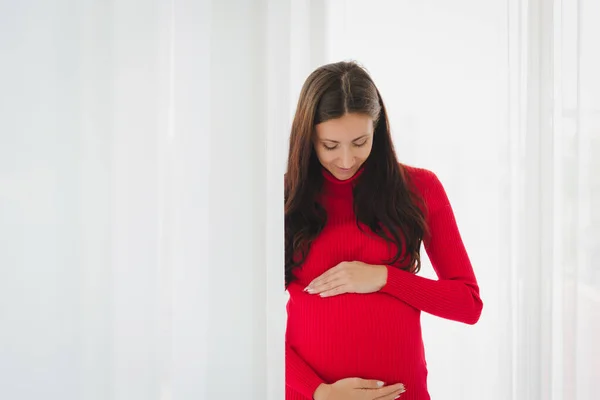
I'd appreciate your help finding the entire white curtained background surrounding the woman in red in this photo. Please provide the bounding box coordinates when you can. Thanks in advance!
[0,0,600,400]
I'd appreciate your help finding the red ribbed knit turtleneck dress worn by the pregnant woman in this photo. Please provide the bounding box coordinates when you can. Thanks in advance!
[285,166,483,400]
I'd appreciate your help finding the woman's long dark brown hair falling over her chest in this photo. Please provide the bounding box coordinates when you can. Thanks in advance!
[285,62,428,288]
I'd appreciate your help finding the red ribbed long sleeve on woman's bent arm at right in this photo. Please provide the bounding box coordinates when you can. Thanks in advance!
[381,170,483,324]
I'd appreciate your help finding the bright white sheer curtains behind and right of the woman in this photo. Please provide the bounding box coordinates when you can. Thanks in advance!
[326,0,600,400]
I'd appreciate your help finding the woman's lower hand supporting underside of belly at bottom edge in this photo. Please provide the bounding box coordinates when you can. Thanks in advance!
[313,378,406,400]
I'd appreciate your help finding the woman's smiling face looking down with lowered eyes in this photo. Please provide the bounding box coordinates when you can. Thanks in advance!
[314,113,374,180]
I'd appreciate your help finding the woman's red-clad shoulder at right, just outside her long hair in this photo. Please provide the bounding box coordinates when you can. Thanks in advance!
[400,164,448,211]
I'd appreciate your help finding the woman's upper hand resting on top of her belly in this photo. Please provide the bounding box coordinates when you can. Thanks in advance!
[304,261,387,297]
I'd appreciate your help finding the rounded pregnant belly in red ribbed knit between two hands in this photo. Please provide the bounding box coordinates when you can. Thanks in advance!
[286,284,427,392]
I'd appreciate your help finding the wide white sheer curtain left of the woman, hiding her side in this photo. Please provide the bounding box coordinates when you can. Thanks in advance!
[0,0,298,400]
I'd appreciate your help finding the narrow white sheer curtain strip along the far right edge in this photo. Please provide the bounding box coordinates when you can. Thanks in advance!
[542,0,600,399]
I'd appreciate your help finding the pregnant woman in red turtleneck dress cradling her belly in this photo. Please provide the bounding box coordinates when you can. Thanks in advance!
[285,62,483,400]
